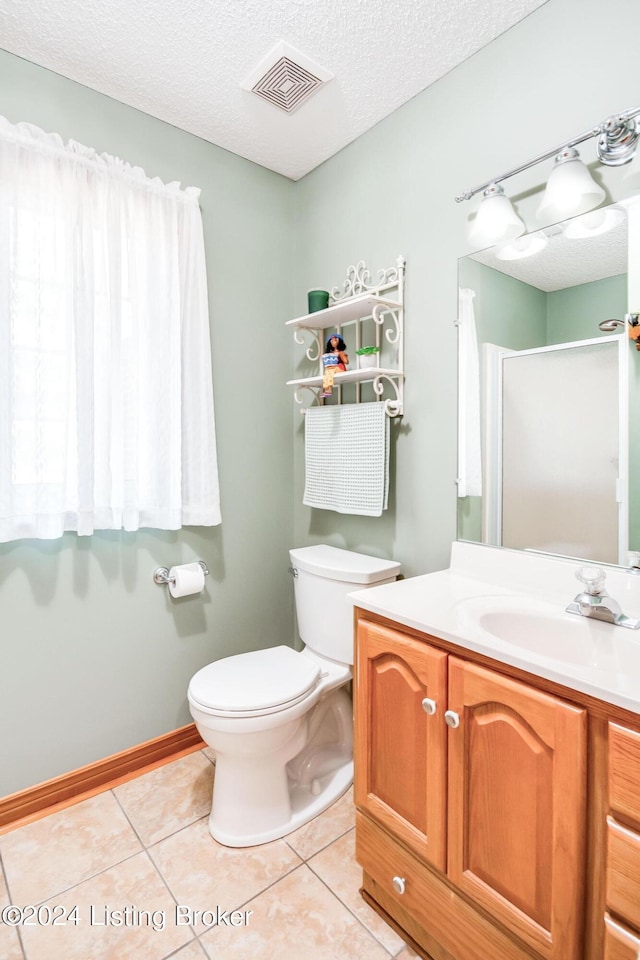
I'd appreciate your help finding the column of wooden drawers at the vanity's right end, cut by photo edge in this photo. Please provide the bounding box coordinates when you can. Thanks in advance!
[604,722,640,960]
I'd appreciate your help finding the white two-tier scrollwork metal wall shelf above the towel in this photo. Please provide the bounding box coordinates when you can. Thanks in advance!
[285,257,405,417]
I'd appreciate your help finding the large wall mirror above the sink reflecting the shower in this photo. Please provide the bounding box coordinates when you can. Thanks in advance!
[458,198,640,566]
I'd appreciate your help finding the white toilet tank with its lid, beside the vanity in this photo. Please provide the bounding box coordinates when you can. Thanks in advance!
[289,544,400,664]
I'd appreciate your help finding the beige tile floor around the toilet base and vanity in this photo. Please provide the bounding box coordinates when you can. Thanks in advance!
[0,750,416,960]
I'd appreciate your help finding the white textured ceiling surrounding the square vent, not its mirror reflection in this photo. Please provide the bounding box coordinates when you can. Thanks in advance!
[0,0,546,180]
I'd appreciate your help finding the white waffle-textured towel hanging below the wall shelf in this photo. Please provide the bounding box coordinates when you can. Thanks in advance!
[302,401,389,517]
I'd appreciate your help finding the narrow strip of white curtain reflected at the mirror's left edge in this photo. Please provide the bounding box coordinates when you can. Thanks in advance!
[458,290,482,497]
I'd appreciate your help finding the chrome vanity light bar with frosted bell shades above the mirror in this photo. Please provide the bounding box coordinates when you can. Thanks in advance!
[456,107,640,245]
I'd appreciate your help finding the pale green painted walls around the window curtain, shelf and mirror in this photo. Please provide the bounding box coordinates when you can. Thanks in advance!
[0,0,640,793]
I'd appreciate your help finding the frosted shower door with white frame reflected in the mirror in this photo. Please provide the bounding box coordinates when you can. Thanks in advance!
[485,337,628,563]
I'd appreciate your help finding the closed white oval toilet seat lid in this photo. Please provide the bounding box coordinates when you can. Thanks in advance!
[189,647,320,713]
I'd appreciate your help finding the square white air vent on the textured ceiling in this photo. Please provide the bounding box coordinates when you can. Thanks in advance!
[240,41,333,113]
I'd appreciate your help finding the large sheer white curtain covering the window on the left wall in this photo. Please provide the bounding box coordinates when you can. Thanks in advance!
[0,117,220,541]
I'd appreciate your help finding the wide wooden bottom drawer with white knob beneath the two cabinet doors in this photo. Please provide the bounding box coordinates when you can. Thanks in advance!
[356,811,531,960]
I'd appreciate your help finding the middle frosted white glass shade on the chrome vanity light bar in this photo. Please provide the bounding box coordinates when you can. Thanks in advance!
[538,147,605,223]
